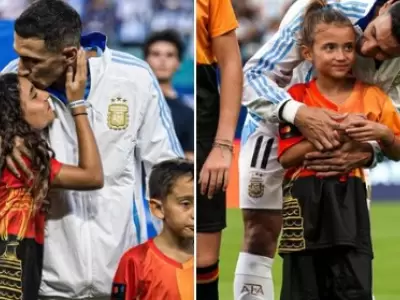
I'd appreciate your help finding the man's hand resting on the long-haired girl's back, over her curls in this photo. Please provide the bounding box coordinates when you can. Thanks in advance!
[6,137,33,181]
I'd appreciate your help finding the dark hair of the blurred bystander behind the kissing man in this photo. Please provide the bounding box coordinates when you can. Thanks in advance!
[143,29,185,61]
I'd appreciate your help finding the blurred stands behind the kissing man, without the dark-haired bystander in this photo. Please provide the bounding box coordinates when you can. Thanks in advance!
[0,0,194,101]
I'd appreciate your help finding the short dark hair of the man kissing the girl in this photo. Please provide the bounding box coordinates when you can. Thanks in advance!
[14,0,82,51]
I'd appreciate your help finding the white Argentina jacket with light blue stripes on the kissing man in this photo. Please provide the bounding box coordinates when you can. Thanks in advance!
[3,32,183,299]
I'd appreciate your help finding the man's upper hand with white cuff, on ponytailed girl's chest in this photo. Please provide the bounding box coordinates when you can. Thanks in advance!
[294,106,347,151]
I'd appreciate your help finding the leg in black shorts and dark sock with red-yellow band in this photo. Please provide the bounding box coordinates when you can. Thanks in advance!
[196,140,226,300]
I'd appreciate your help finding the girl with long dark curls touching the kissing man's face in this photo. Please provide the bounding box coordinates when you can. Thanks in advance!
[0,50,103,300]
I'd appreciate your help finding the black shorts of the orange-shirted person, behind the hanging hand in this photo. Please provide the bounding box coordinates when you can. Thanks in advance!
[196,138,226,233]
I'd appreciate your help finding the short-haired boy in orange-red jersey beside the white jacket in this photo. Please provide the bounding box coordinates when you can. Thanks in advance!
[111,159,194,300]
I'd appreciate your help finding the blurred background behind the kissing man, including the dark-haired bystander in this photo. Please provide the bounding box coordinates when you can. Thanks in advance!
[0,0,194,152]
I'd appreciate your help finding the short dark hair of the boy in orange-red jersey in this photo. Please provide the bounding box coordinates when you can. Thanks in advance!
[149,158,194,200]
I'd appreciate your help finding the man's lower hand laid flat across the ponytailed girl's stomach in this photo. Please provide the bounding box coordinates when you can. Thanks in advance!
[304,140,373,177]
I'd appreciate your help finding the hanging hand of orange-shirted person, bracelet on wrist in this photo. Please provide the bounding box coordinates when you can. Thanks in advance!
[199,147,232,199]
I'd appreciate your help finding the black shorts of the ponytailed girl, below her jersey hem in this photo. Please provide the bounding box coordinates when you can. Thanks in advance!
[280,247,372,300]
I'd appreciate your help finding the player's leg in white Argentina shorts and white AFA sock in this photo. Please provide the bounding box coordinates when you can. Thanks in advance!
[234,129,283,300]
